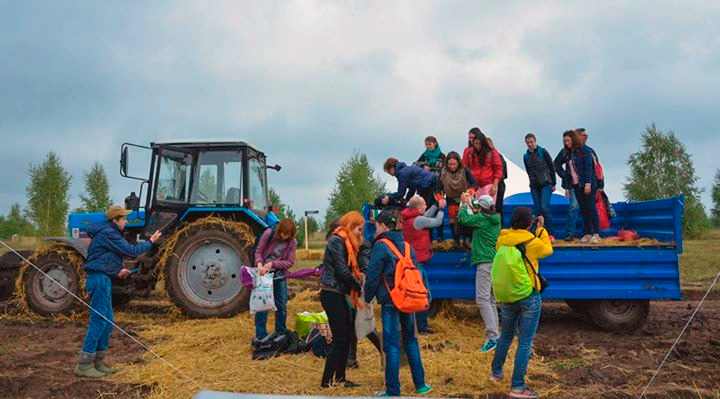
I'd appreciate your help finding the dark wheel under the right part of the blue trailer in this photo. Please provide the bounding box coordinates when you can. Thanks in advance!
[587,299,650,333]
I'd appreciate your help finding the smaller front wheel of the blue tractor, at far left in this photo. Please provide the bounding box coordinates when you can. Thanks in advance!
[23,252,80,316]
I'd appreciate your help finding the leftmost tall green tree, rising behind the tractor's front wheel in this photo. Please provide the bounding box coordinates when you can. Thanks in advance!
[25,152,72,236]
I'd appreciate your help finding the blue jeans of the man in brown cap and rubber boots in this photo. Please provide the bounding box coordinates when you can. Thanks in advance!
[82,273,114,353]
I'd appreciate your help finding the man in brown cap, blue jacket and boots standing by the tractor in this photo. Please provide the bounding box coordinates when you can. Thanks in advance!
[74,206,161,378]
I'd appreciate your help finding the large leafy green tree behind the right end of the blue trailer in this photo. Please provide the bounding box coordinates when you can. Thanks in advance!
[624,123,708,237]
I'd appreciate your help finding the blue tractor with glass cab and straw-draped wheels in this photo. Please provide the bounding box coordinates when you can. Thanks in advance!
[16,141,280,318]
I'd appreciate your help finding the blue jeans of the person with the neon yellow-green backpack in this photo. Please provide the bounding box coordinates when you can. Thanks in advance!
[492,291,542,389]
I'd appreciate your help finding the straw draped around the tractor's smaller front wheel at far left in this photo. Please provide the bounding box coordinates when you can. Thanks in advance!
[13,243,88,320]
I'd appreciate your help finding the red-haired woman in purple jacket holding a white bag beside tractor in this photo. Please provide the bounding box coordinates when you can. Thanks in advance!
[255,219,297,341]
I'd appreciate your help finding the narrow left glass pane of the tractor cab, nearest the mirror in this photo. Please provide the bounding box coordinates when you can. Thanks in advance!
[157,151,192,202]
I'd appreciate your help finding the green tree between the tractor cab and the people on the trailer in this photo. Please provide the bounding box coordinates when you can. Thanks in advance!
[325,151,385,226]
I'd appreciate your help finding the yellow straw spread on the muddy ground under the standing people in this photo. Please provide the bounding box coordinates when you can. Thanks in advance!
[112,290,557,399]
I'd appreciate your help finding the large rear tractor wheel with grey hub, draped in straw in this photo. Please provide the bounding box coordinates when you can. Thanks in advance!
[164,226,250,318]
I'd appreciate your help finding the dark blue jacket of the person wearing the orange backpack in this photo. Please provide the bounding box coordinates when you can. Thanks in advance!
[365,230,430,305]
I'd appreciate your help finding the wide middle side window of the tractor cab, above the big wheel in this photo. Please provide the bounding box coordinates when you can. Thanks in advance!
[190,151,242,205]
